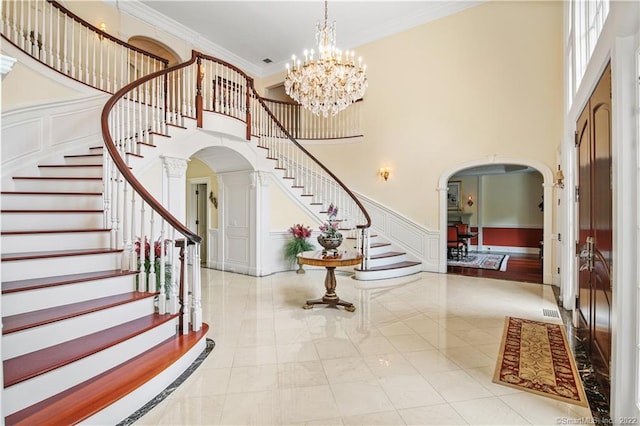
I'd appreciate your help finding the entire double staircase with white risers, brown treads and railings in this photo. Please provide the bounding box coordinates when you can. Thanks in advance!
[1,1,421,425]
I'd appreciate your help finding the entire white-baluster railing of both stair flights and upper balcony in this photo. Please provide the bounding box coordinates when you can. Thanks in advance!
[1,0,371,278]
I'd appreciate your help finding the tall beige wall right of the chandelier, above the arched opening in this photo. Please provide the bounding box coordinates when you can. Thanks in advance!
[282,1,563,229]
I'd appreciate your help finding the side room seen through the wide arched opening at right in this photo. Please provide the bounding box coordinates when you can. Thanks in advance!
[447,164,544,283]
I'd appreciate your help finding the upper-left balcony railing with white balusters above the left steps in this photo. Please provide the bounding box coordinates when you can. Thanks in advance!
[0,0,169,93]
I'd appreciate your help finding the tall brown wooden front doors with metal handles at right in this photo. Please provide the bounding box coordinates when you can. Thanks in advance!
[577,62,613,398]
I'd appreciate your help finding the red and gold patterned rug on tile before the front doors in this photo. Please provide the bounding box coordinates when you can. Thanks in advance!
[493,317,589,407]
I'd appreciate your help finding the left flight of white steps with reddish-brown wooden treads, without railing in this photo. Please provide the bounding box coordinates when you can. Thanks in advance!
[1,146,208,425]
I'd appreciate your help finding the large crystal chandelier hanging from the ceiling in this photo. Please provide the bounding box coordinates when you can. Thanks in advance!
[284,0,368,117]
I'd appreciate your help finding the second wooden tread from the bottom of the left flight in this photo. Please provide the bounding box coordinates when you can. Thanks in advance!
[3,314,178,388]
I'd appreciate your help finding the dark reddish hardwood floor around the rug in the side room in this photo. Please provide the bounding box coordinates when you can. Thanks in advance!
[447,253,542,283]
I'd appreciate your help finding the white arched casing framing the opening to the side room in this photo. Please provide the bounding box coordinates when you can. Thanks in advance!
[438,156,557,284]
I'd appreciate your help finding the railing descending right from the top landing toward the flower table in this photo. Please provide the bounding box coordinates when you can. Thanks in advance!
[195,53,371,268]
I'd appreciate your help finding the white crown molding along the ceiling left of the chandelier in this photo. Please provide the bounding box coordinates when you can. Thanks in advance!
[103,0,264,77]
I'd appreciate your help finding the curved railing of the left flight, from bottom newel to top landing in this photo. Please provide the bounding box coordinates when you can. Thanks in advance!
[101,55,202,334]
